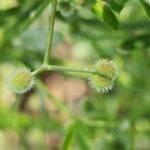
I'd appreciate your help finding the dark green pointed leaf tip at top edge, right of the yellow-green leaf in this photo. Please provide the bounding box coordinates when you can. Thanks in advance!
[106,0,128,13]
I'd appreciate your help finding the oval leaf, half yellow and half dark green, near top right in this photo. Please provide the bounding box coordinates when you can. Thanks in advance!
[92,1,119,30]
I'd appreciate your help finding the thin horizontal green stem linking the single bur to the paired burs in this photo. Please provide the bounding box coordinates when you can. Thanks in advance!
[32,65,95,76]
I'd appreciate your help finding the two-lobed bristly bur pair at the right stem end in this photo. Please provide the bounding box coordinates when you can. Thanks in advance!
[90,59,117,93]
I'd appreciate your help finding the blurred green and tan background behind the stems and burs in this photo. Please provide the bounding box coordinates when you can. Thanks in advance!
[0,0,150,150]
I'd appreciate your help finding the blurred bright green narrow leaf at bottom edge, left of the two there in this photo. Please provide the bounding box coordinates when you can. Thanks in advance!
[62,122,76,150]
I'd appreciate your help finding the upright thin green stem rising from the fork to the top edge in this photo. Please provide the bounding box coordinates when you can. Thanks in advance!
[43,0,57,65]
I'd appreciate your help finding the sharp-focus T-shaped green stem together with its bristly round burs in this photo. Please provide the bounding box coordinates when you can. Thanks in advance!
[9,0,117,94]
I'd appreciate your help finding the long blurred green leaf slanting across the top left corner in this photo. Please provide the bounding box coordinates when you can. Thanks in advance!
[2,0,50,45]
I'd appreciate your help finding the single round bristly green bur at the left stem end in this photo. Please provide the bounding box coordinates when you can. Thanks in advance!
[9,68,34,94]
